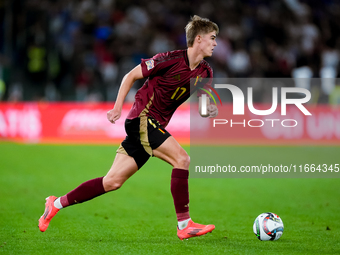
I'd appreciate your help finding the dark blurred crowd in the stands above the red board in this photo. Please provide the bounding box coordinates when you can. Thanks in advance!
[0,0,340,101]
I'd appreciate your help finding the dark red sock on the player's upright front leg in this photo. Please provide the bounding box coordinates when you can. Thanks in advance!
[171,168,190,221]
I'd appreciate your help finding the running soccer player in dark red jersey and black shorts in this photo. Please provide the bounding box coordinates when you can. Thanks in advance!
[39,15,219,240]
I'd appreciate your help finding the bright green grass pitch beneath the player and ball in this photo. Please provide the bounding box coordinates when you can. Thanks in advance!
[0,142,340,254]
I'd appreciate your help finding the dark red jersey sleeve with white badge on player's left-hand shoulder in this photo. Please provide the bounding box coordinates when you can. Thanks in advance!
[141,53,170,78]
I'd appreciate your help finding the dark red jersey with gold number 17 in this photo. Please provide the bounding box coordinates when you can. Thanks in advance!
[127,50,213,127]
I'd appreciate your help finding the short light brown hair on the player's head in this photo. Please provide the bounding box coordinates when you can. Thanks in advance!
[185,15,219,47]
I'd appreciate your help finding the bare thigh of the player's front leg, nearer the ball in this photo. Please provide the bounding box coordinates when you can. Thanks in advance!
[153,136,190,169]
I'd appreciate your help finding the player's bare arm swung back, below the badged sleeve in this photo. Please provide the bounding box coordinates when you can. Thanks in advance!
[107,65,144,124]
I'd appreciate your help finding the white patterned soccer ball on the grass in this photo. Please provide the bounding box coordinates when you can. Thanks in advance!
[253,212,283,241]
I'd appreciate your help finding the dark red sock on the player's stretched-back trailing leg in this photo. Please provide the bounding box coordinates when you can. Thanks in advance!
[60,177,105,207]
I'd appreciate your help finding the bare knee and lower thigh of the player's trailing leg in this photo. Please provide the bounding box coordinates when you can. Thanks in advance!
[103,153,138,191]
